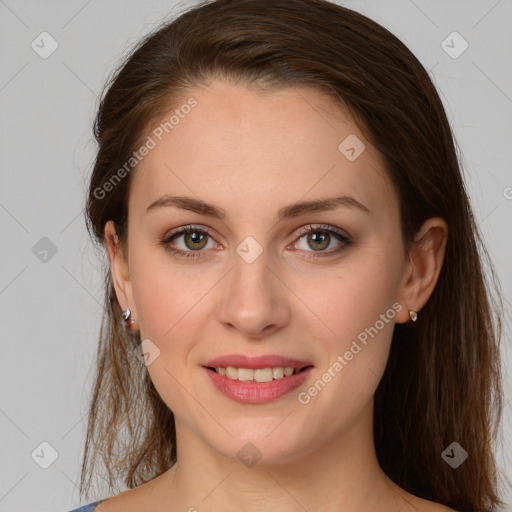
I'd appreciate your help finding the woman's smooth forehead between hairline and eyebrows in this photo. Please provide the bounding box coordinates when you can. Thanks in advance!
[130,81,397,223]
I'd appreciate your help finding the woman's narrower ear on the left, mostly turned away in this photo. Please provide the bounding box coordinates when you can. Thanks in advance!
[105,220,138,318]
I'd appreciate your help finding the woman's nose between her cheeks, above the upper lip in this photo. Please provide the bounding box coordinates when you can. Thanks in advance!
[216,251,290,339]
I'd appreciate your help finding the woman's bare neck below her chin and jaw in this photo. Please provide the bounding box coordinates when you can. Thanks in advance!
[161,401,411,512]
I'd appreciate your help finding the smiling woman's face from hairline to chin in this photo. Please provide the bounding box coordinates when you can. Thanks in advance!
[108,81,416,462]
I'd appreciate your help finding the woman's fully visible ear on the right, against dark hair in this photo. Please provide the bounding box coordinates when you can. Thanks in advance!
[396,217,448,323]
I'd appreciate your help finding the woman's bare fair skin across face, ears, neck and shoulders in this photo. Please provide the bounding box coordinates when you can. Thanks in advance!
[97,80,450,512]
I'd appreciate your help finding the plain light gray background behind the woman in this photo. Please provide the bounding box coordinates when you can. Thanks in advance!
[0,0,512,512]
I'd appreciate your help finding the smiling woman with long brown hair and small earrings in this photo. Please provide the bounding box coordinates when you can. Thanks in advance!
[67,0,502,512]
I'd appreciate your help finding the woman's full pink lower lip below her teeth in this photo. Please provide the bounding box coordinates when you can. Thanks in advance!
[203,366,313,404]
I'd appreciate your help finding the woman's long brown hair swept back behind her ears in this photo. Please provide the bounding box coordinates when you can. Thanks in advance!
[80,0,503,512]
